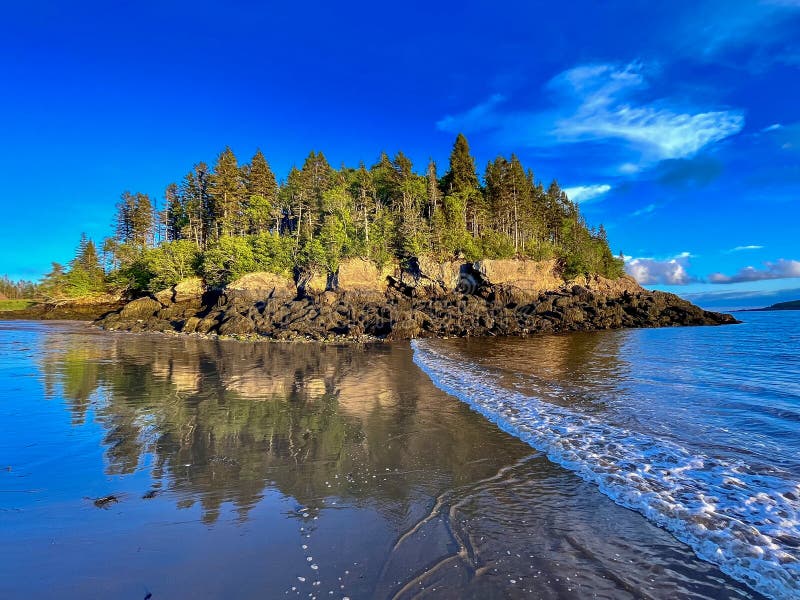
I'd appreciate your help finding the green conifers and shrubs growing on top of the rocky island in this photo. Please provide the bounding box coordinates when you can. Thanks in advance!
[43,134,623,295]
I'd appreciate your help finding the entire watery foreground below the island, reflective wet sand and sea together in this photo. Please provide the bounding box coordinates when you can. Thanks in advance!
[0,314,800,600]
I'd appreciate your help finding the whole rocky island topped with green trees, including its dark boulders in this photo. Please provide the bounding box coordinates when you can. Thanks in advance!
[4,134,737,340]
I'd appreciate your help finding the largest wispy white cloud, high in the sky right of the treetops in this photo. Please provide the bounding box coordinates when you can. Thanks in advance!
[437,63,744,164]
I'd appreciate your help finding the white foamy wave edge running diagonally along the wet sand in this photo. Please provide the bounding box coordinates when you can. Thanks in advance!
[412,340,800,598]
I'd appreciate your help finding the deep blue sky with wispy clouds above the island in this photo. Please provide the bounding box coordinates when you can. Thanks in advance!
[0,0,800,307]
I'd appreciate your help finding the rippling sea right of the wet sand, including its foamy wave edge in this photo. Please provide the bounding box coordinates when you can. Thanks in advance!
[412,311,800,598]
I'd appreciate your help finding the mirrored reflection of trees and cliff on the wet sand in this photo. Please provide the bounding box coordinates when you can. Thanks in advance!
[37,334,520,522]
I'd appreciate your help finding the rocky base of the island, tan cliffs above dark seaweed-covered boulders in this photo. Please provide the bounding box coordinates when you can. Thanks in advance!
[99,260,737,340]
